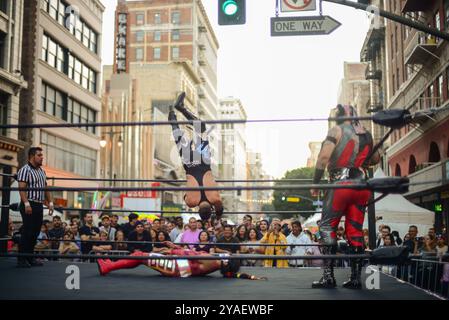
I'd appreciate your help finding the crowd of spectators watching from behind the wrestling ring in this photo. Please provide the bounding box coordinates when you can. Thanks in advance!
[5,213,448,268]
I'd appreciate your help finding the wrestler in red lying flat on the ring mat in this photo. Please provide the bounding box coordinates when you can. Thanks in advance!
[97,242,266,280]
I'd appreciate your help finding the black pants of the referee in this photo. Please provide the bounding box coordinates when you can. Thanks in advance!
[19,201,44,260]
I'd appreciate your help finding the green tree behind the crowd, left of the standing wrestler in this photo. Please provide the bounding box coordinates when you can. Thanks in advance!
[273,168,315,219]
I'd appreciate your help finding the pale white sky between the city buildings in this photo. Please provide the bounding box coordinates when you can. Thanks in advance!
[102,0,369,178]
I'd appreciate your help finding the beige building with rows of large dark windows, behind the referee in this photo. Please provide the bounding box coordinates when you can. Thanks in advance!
[19,0,105,211]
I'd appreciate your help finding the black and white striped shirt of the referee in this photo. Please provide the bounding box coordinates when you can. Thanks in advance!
[17,163,47,201]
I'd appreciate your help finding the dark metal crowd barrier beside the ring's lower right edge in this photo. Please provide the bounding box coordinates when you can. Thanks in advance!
[387,256,449,300]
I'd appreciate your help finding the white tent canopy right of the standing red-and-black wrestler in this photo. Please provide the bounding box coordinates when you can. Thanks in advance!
[365,168,435,238]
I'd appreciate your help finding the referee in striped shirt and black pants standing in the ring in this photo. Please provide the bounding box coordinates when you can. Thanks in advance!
[17,147,54,268]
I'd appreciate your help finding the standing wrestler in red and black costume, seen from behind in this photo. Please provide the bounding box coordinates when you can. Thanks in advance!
[311,105,380,289]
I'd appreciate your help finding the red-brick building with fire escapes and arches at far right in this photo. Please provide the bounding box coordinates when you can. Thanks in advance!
[385,0,449,232]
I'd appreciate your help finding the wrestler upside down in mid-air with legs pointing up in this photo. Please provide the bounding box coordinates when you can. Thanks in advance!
[168,92,223,220]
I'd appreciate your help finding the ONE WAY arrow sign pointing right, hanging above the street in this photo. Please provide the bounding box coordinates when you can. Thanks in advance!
[271,16,341,37]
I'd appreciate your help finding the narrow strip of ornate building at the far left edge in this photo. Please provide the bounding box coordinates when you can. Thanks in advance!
[0,0,27,173]
